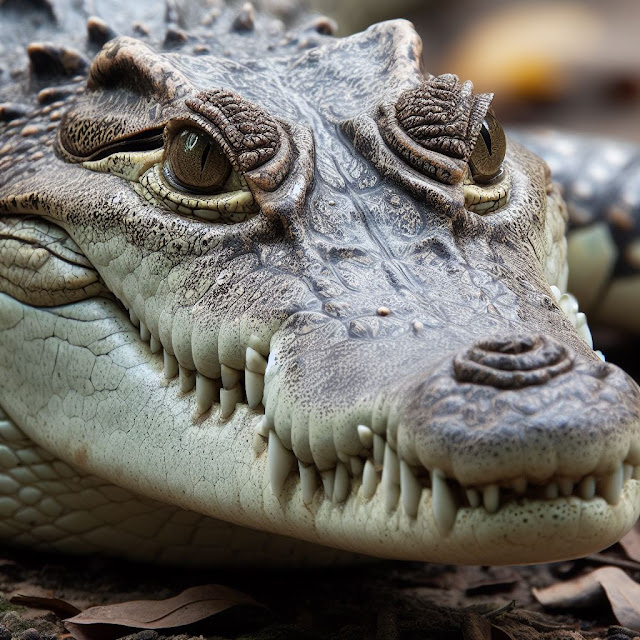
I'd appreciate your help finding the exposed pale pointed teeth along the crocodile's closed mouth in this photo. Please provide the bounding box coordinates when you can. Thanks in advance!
[119,287,640,535]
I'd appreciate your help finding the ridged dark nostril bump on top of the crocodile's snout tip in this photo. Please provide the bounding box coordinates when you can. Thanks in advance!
[453,335,573,389]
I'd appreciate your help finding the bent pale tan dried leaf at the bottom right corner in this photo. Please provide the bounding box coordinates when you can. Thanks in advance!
[533,567,640,631]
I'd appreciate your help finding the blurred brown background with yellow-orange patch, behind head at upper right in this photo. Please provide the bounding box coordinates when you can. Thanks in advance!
[312,0,640,142]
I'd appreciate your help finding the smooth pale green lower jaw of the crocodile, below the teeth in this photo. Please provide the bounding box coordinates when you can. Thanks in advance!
[0,296,640,564]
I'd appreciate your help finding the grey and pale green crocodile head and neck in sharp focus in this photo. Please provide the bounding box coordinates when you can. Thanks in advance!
[0,4,640,565]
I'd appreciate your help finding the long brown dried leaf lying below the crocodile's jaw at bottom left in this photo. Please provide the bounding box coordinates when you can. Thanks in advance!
[65,584,263,640]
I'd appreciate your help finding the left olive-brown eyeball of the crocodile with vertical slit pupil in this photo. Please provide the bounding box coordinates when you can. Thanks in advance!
[164,127,231,194]
